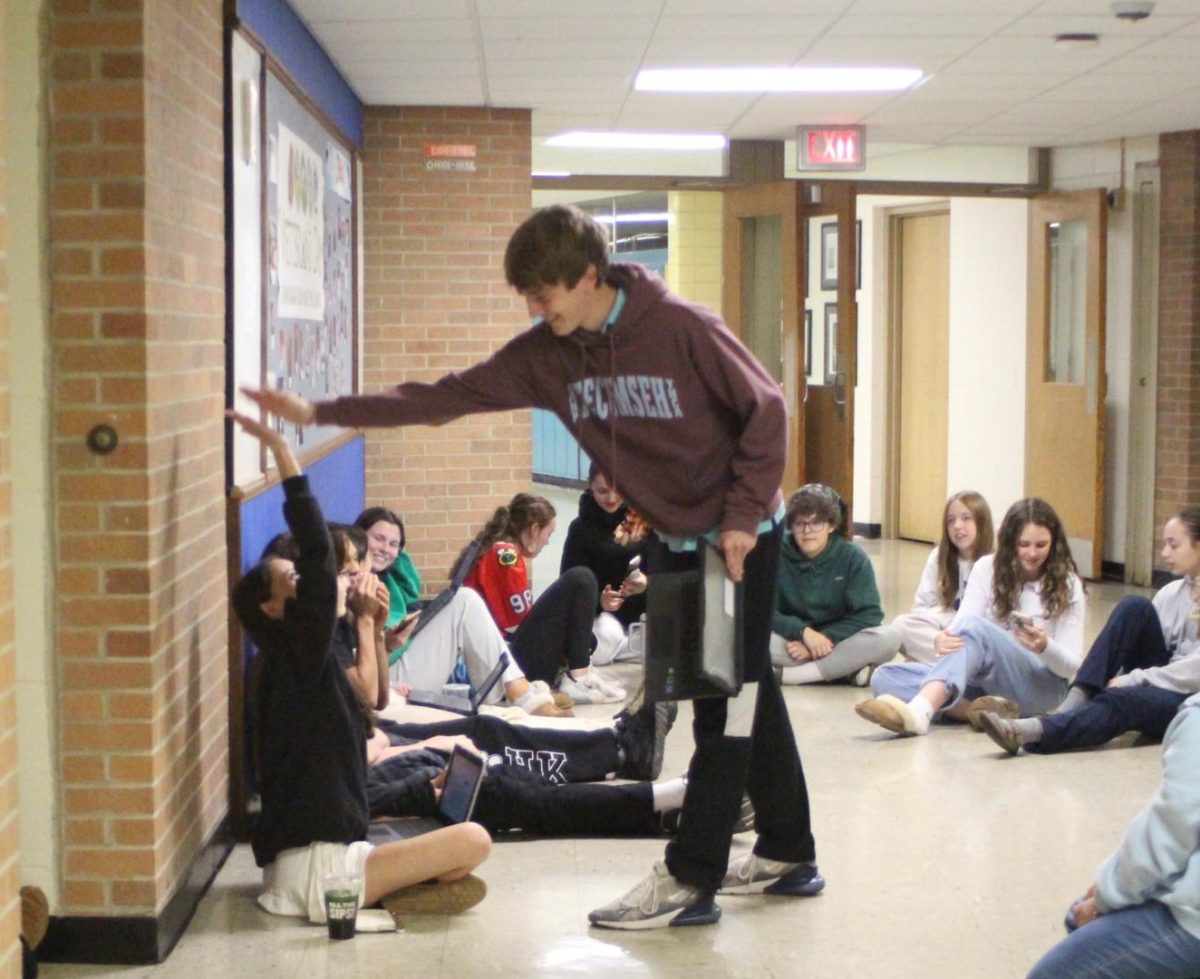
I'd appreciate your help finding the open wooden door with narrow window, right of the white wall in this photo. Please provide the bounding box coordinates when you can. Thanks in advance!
[1025,190,1108,578]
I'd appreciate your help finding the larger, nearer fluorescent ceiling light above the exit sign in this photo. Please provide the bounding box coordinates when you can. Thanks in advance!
[634,68,922,92]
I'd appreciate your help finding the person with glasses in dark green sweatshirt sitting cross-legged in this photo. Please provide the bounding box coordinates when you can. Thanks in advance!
[770,482,900,686]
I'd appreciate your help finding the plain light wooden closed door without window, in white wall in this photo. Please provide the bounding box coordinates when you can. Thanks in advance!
[892,211,950,542]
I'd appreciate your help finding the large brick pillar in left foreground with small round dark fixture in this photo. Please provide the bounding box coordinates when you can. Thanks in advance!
[48,0,227,915]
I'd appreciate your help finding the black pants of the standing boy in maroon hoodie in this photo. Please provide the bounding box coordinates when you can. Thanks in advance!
[655,527,816,891]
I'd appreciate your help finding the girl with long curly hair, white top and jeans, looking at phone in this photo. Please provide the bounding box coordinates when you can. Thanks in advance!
[854,497,1085,734]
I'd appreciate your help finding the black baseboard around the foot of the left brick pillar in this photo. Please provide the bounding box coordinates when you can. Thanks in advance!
[37,816,234,966]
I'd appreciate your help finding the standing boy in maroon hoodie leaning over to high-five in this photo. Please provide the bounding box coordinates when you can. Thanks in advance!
[246,206,824,929]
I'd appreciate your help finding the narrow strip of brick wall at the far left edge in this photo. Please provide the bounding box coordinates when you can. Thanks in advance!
[0,0,22,979]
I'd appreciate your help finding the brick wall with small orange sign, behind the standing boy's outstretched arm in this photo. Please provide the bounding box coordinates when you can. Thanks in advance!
[360,108,530,580]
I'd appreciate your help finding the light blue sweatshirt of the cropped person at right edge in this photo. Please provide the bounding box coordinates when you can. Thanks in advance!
[1096,693,1200,938]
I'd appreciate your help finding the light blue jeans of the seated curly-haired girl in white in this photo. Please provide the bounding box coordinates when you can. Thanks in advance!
[871,615,1067,717]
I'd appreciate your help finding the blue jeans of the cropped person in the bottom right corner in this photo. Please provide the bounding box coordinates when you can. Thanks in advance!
[1028,901,1200,979]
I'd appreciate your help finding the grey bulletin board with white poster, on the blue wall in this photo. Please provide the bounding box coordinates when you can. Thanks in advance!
[263,68,358,452]
